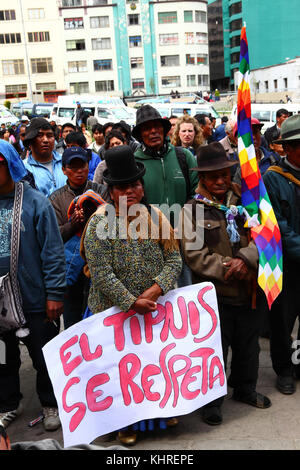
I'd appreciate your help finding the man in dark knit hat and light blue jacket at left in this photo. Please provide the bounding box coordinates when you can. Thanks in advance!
[23,118,67,197]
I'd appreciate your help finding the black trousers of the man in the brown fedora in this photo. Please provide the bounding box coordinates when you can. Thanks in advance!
[205,303,260,407]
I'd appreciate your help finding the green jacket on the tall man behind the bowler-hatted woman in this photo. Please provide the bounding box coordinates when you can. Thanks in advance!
[134,143,198,214]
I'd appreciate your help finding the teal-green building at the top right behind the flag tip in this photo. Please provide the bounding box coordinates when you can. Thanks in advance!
[208,0,300,89]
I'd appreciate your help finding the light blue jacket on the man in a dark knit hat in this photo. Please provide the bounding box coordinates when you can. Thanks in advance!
[24,150,67,197]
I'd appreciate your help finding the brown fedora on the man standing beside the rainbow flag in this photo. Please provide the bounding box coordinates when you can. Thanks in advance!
[191,142,238,171]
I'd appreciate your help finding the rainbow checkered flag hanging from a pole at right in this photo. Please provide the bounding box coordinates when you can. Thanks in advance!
[237,26,282,308]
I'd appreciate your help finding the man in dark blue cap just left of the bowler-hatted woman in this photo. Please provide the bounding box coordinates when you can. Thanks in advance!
[49,145,109,328]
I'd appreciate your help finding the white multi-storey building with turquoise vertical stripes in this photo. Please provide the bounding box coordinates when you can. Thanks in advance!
[59,0,209,96]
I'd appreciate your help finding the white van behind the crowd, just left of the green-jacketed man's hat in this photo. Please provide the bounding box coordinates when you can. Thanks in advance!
[50,95,135,126]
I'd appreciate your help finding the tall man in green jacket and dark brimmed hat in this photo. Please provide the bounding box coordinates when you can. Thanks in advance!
[132,105,197,287]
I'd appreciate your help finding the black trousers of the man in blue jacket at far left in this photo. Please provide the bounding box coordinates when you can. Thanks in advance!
[0,313,60,412]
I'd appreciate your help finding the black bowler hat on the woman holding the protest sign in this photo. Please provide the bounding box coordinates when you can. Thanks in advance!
[103,145,146,185]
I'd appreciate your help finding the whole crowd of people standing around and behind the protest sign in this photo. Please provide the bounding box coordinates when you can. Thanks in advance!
[0,105,300,445]
